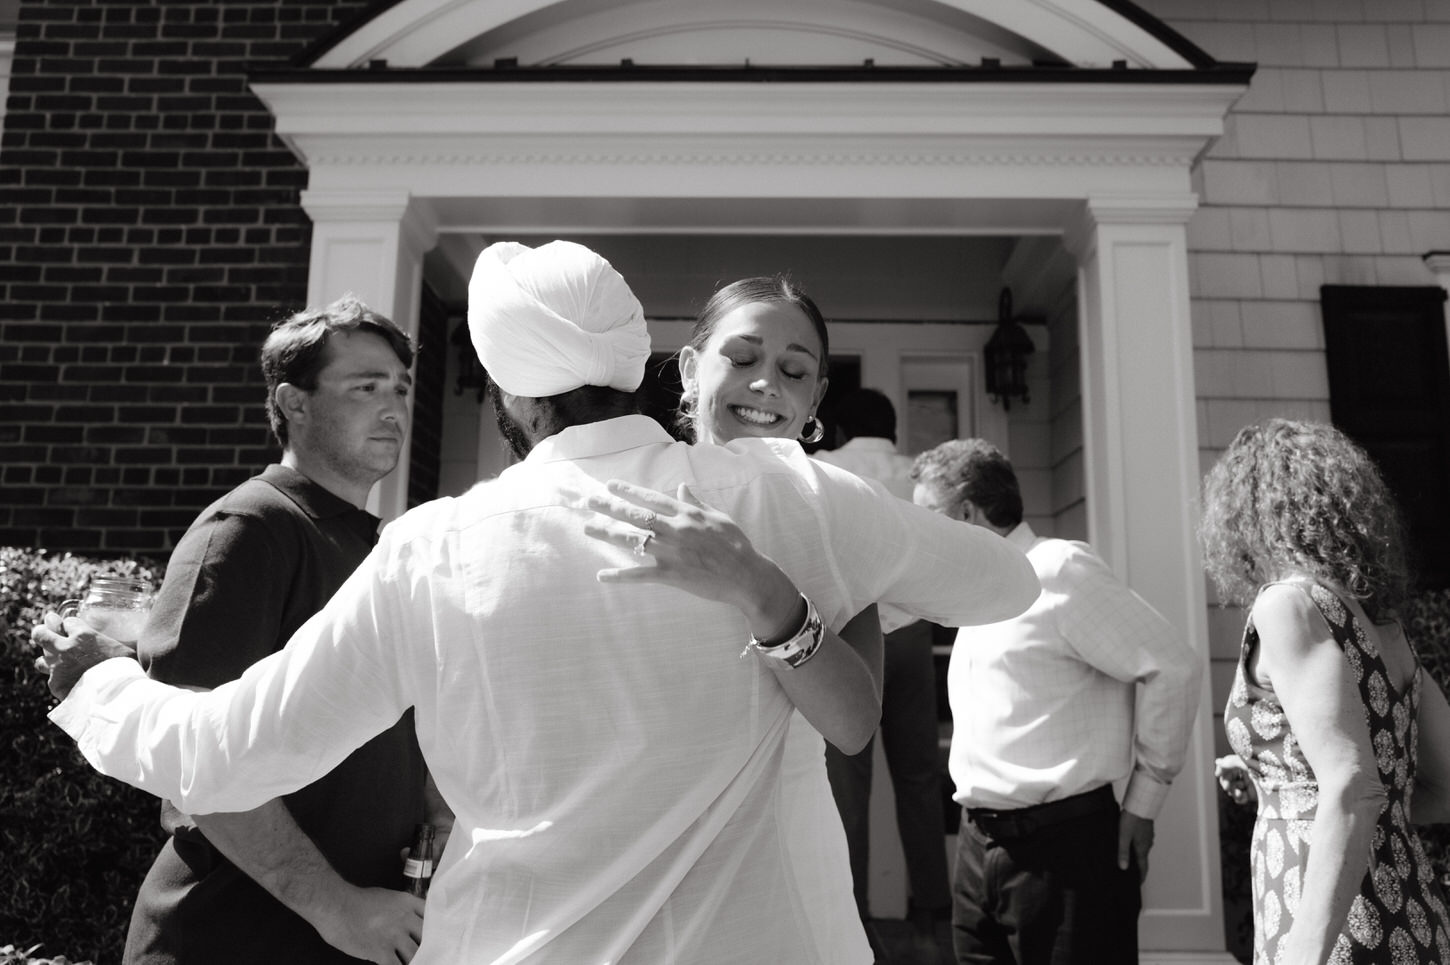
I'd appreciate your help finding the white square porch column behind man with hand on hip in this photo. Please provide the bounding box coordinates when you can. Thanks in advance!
[1067,194,1233,964]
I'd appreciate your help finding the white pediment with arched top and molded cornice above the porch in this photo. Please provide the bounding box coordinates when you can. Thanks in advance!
[263,0,1248,240]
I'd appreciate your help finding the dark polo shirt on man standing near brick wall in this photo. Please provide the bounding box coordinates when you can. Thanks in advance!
[125,465,425,965]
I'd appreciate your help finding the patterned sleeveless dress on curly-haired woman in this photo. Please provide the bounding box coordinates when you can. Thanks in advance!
[1224,582,1450,965]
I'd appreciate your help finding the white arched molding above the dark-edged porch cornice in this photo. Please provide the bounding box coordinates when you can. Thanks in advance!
[309,0,1202,70]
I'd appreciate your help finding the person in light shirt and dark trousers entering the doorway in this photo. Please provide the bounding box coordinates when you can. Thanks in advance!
[816,388,951,945]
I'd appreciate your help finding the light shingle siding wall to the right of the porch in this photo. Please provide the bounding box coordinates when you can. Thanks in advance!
[1140,0,1450,749]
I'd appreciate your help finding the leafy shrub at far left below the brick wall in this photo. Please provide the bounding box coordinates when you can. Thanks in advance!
[0,546,162,965]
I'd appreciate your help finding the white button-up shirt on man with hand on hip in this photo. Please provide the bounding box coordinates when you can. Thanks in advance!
[947,523,1204,819]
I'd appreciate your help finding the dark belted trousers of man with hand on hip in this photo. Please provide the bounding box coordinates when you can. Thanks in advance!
[951,785,1143,965]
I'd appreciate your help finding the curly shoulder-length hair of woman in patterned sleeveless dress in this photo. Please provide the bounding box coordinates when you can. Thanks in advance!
[1198,419,1411,622]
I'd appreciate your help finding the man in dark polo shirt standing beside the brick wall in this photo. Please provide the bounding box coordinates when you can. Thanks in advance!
[125,297,451,965]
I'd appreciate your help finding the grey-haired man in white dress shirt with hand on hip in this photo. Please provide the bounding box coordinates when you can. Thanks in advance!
[912,439,1202,965]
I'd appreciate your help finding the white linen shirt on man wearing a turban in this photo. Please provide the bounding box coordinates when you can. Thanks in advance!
[52,416,1037,965]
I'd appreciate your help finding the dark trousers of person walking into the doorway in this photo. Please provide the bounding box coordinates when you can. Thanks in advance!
[825,622,951,922]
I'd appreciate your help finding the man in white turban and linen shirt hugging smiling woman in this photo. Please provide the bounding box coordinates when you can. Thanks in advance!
[33,243,1038,965]
